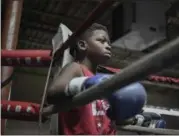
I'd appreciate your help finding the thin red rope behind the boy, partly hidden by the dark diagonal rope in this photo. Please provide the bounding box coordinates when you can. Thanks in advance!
[99,66,179,84]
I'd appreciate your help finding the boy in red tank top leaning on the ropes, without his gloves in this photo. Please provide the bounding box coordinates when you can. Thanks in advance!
[44,24,148,135]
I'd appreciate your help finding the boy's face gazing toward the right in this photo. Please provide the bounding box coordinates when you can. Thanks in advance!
[86,30,112,64]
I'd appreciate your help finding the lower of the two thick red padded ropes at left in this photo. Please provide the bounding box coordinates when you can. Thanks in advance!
[1,100,48,121]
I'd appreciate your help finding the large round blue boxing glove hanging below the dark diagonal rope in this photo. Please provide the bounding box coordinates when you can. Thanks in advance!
[107,83,147,124]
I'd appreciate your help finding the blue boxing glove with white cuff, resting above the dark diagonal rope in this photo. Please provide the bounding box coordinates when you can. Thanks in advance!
[65,74,112,96]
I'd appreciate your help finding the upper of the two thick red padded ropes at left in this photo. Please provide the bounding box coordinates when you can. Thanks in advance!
[1,50,51,67]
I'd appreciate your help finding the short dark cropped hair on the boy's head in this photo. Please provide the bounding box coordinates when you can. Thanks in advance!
[70,23,108,57]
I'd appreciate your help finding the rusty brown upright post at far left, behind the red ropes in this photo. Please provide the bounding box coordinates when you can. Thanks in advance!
[1,0,23,135]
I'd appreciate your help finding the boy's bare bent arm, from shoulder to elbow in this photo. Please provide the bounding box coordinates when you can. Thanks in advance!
[47,63,82,104]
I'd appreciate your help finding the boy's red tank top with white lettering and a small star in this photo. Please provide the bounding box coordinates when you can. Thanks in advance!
[59,65,116,135]
